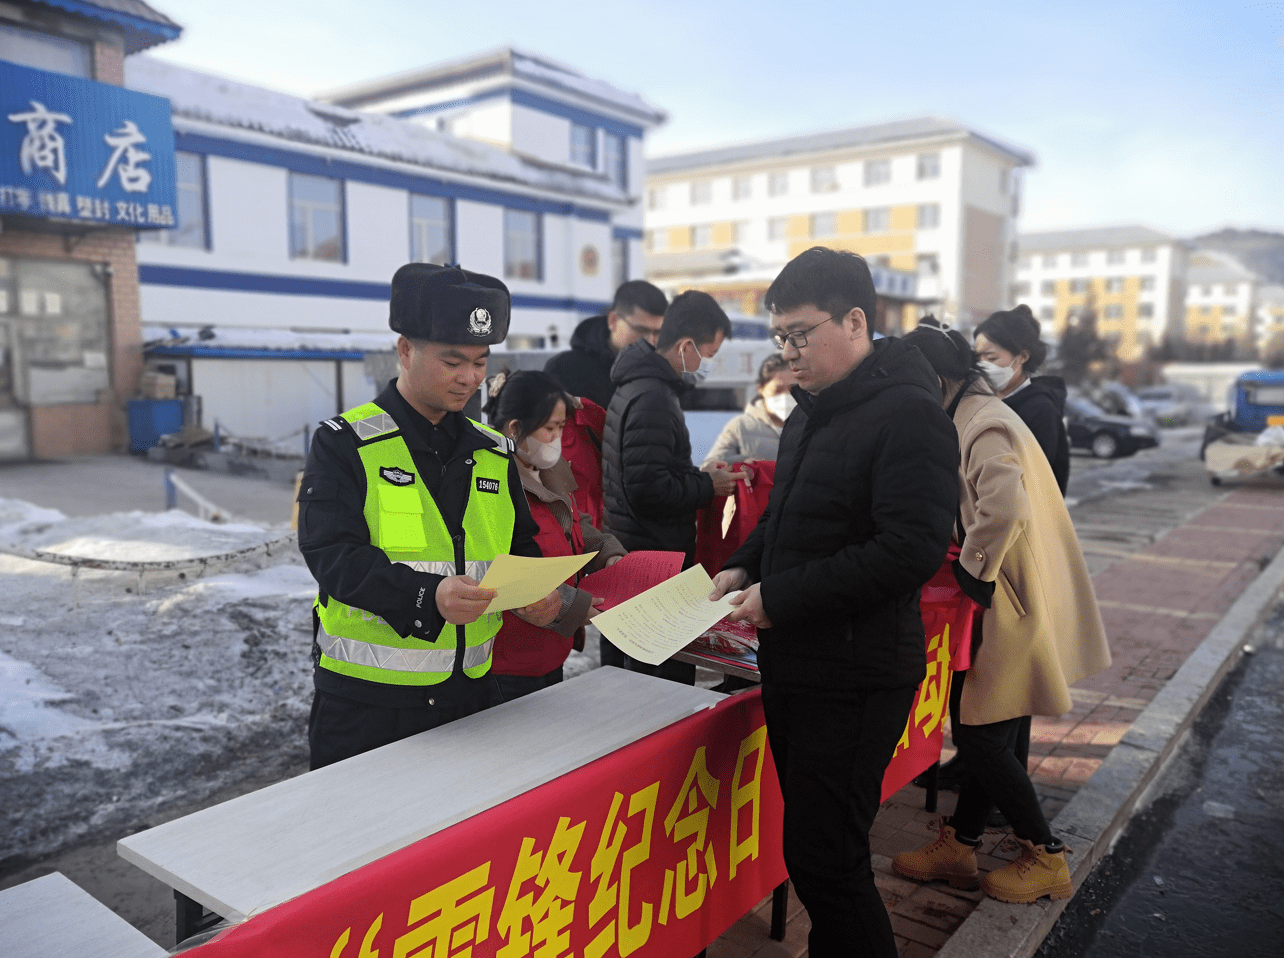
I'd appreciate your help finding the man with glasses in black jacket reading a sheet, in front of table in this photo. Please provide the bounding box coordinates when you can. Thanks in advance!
[714,247,959,958]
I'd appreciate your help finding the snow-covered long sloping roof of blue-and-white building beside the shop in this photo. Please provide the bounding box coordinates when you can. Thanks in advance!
[125,57,629,204]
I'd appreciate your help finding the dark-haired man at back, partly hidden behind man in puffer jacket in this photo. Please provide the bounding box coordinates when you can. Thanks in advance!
[544,280,669,410]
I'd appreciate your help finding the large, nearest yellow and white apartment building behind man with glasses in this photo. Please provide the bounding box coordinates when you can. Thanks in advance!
[645,117,1034,333]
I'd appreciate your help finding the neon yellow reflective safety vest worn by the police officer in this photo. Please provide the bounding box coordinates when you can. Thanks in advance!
[315,402,515,686]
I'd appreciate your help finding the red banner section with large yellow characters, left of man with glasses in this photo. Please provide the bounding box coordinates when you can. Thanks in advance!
[191,691,786,958]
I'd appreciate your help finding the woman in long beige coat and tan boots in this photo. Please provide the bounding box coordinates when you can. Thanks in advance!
[892,320,1111,903]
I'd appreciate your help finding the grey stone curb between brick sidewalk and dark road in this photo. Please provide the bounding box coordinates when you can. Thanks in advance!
[936,541,1284,958]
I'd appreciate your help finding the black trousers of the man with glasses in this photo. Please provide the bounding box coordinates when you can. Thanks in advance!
[763,682,914,958]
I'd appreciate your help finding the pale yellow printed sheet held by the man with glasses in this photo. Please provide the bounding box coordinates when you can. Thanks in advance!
[593,565,738,665]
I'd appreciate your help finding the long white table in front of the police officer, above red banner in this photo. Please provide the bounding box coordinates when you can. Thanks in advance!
[117,668,724,941]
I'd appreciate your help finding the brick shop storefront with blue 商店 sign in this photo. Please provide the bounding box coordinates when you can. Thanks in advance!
[0,4,176,460]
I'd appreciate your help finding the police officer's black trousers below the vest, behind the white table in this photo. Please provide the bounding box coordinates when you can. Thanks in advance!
[308,675,499,769]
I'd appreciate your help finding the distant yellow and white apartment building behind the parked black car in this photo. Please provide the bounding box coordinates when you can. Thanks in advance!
[1012,226,1186,362]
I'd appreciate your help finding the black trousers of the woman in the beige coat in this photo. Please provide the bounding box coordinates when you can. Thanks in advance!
[950,672,1052,845]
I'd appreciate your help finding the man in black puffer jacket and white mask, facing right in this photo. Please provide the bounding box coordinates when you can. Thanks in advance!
[602,290,749,681]
